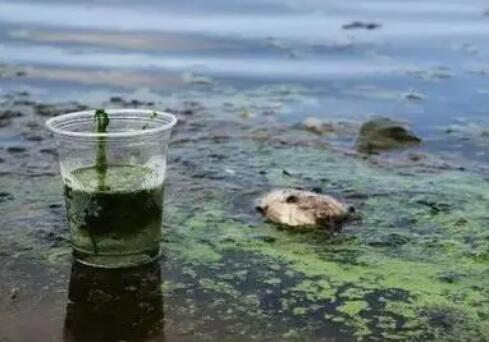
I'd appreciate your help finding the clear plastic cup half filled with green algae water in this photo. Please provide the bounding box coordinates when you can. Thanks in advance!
[46,109,177,268]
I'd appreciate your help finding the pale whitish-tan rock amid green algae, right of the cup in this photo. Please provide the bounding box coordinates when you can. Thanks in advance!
[257,189,353,230]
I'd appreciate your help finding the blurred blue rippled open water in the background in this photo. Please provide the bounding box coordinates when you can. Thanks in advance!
[0,0,489,160]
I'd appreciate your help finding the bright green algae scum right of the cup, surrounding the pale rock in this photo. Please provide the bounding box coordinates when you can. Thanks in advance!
[158,135,489,341]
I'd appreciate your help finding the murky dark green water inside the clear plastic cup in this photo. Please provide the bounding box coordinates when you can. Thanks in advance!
[64,165,163,266]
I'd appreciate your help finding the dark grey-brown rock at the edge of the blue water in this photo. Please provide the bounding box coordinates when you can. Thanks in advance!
[356,118,421,153]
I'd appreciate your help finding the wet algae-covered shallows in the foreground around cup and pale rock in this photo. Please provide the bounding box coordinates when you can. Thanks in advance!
[0,89,489,341]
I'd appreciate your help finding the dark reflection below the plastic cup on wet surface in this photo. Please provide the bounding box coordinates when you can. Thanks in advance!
[64,262,165,342]
